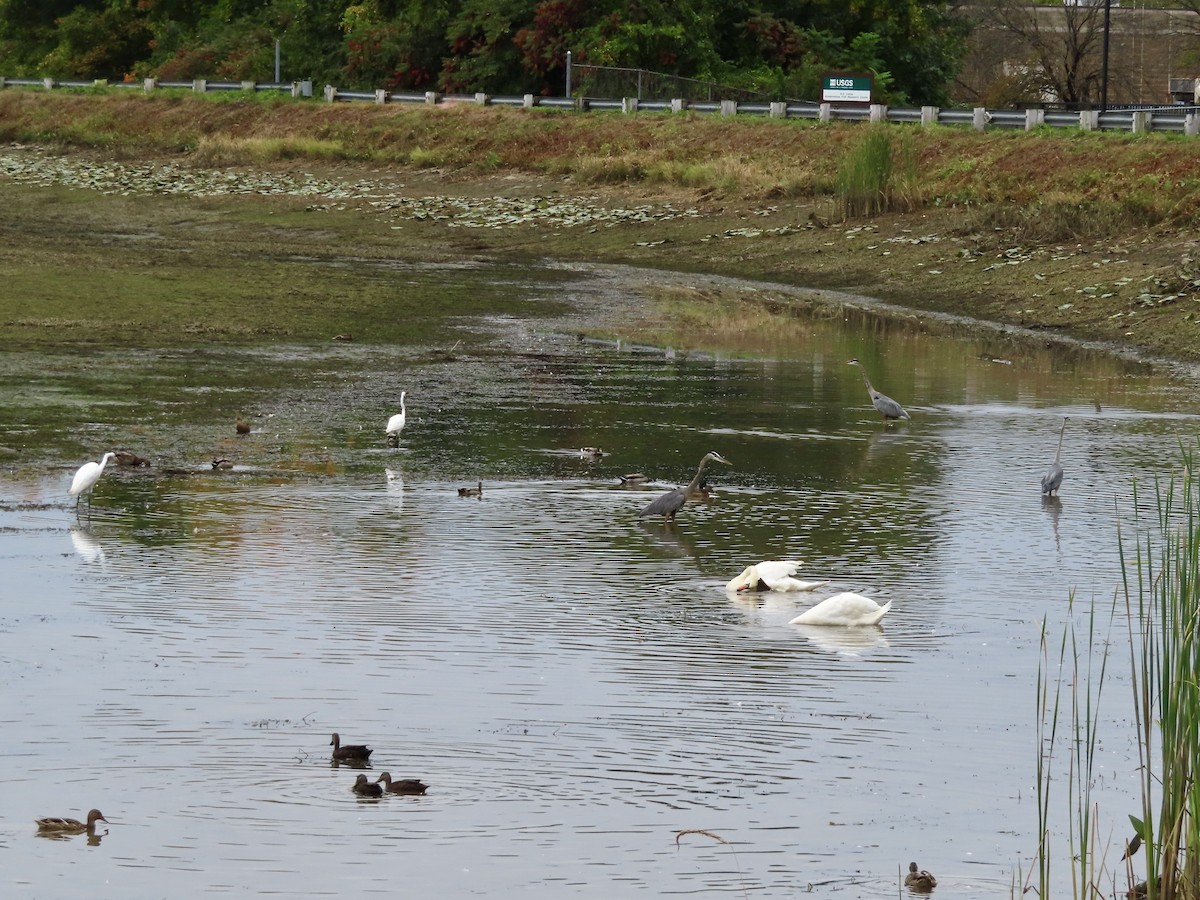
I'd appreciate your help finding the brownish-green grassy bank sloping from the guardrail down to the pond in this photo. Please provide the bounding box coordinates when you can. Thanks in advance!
[0,90,1200,360]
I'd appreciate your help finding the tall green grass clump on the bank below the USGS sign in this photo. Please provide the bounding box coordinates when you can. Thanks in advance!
[836,125,918,218]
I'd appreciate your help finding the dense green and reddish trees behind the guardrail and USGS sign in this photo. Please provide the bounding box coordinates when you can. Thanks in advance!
[0,0,970,104]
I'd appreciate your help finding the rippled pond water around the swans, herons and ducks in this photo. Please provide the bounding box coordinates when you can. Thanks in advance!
[0,259,1198,898]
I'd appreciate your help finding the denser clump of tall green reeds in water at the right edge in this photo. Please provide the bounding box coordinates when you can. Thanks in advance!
[1122,452,1200,900]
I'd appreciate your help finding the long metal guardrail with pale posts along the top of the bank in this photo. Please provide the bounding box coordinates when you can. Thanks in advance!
[7,77,1200,137]
